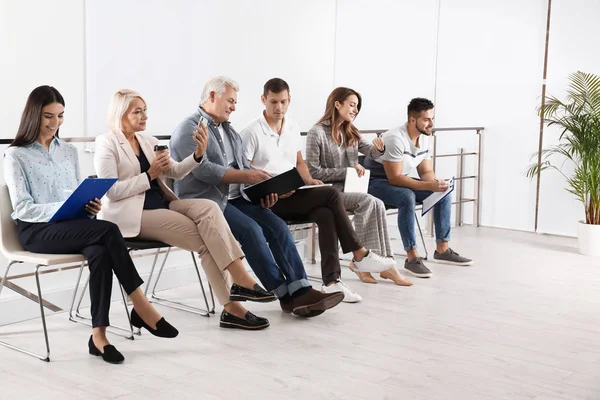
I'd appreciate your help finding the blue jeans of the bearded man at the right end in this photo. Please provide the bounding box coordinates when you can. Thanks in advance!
[369,178,452,251]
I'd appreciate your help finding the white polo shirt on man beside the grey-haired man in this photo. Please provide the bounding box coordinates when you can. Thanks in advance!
[240,115,302,175]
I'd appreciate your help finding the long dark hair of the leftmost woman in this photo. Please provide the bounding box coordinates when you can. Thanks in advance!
[10,85,65,147]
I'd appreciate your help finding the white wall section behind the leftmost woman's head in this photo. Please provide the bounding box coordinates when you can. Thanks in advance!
[0,0,85,139]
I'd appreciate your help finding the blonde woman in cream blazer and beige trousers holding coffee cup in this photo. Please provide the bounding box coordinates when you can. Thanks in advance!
[94,89,275,330]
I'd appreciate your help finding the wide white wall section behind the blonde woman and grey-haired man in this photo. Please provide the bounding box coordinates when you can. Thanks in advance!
[86,0,335,136]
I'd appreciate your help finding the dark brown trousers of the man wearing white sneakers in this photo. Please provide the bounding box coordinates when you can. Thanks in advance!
[271,186,362,285]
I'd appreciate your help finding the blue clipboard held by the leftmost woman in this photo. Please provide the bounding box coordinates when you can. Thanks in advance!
[49,178,118,222]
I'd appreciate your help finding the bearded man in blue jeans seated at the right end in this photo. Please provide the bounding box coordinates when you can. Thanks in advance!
[365,98,473,278]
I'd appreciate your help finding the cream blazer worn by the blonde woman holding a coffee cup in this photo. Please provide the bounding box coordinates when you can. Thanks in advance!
[94,132,198,237]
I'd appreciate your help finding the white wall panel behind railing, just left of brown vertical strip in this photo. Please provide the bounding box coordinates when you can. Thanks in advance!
[436,0,546,230]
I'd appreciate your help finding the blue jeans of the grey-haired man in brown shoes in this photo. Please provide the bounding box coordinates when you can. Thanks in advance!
[223,197,311,298]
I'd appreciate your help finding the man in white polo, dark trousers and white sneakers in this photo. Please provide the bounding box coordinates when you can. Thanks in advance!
[241,78,394,303]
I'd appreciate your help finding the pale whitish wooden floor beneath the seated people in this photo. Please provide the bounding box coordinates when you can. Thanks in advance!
[0,227,600,400]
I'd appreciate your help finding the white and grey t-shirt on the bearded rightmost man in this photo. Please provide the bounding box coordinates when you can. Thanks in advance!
[376,124,433,176]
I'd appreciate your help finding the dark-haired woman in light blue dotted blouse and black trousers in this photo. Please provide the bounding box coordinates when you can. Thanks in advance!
[4,86,178,364]
